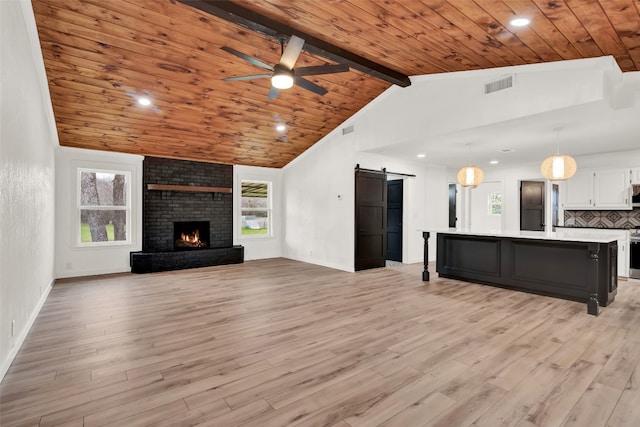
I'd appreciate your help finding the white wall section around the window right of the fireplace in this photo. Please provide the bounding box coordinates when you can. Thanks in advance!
[233,165,284,260]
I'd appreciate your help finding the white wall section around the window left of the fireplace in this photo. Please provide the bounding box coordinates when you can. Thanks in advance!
[55,147,144,278]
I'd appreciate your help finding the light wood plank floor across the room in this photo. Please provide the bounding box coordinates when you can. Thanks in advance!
[0,259,640,427]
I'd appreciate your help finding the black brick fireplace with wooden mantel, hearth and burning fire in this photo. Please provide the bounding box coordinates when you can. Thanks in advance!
[130,157,244,273]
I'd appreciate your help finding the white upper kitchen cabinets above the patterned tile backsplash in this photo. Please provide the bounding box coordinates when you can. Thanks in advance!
[563,169,632,210]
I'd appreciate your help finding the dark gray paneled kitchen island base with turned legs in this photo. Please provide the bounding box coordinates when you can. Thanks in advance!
[423,232,618,315]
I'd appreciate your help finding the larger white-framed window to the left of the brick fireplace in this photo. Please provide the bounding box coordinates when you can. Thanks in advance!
[78,168,131,246]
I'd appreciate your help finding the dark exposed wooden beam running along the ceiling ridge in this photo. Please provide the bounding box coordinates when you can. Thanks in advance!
[178,0,411,87]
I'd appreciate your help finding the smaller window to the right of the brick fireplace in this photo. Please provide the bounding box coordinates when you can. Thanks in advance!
[240,181,271,236]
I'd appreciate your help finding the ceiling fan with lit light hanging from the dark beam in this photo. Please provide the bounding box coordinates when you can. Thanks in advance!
[221,36,349,99]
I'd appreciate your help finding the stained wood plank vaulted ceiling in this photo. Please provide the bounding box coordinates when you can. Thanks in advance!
[33,0,640,167]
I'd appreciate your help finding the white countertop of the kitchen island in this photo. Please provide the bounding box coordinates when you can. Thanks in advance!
[424,228,620,243]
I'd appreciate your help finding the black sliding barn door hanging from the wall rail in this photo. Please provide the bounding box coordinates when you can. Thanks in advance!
[355,168,387,271]
